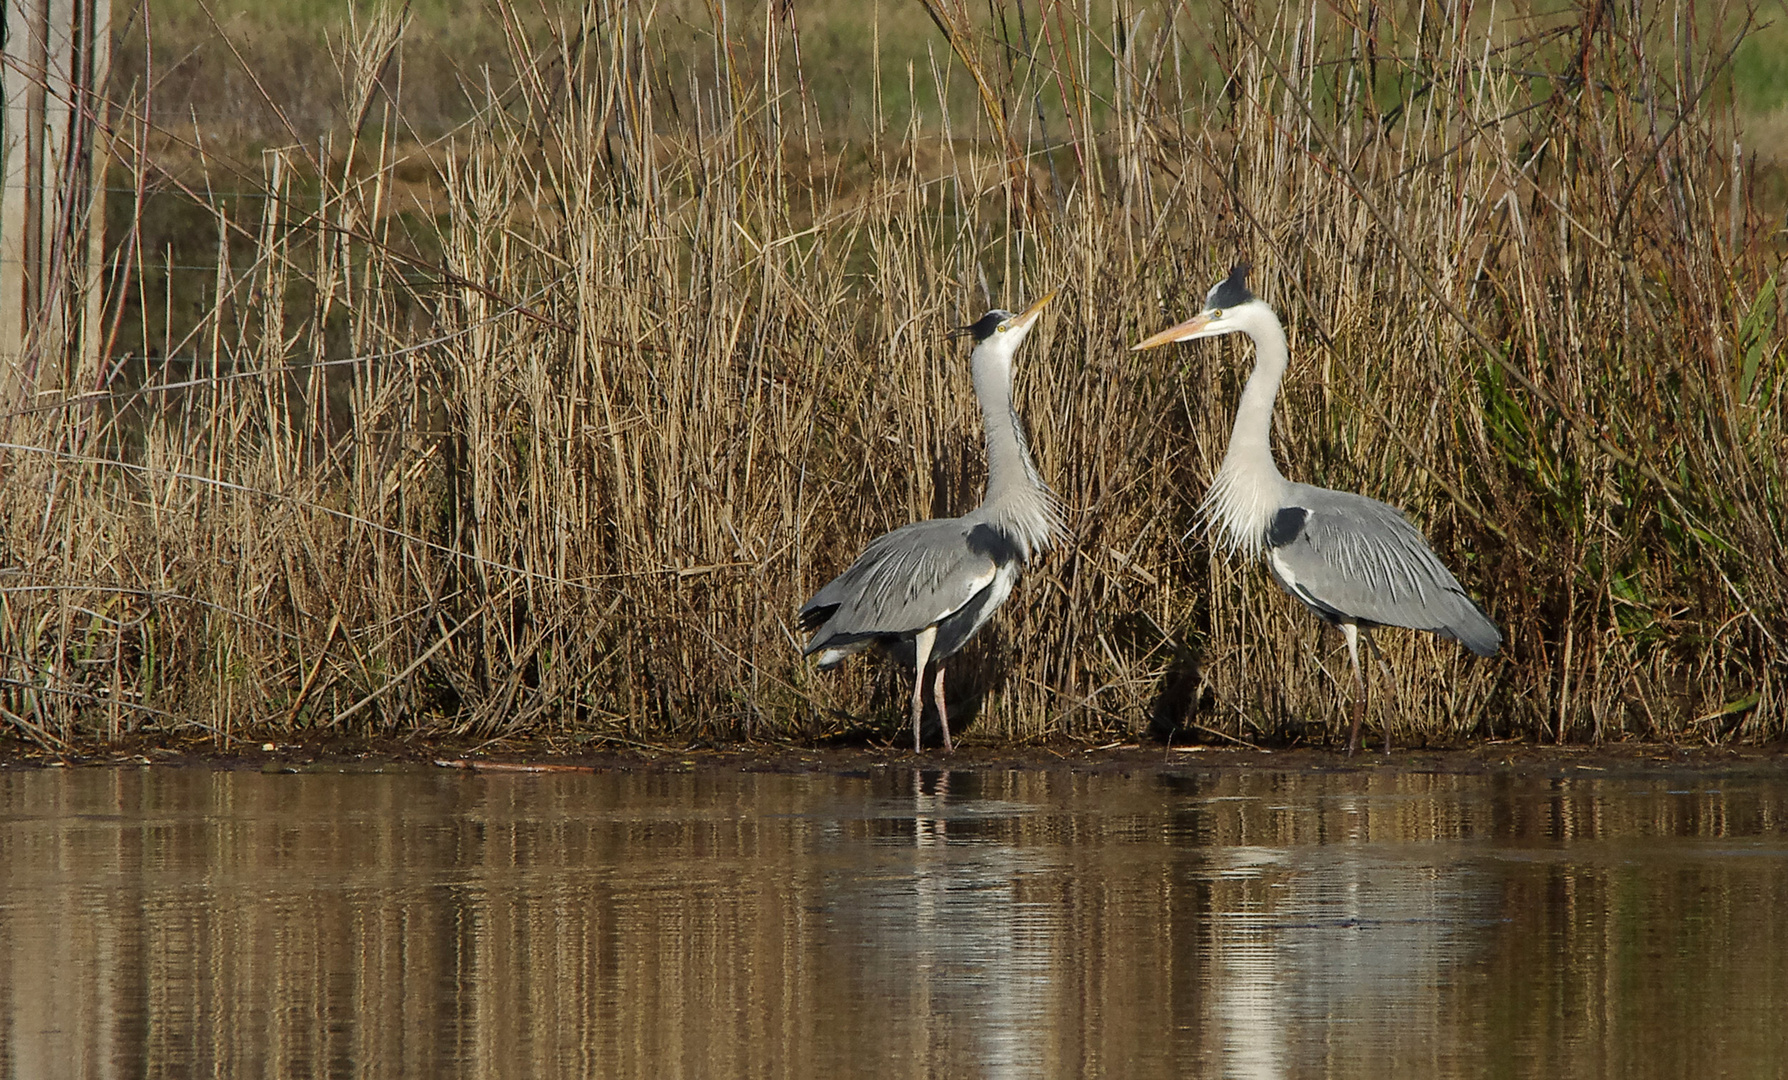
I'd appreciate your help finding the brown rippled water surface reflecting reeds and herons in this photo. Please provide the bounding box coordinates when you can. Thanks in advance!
[0,767,1788,1078]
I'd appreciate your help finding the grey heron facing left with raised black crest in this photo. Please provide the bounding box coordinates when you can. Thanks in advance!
[1135,263,1502,755]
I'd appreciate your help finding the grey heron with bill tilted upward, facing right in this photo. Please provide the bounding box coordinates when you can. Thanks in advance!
[801,293,1062,753]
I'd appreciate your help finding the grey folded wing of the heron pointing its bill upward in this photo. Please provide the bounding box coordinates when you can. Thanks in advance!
[801,519,998,654]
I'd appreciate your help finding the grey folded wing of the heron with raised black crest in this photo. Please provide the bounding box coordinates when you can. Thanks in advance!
[1268,485,1502,656]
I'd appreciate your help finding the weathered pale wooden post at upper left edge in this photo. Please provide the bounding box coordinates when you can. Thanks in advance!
[0,0,111,409]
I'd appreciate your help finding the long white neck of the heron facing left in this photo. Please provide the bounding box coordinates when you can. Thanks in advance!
[1203,306,1289,554]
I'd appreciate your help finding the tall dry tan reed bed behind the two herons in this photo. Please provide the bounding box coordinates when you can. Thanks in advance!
[0,0,1788,749]
